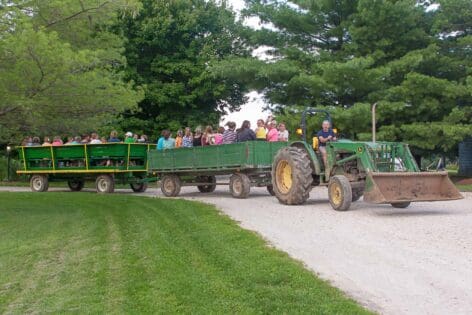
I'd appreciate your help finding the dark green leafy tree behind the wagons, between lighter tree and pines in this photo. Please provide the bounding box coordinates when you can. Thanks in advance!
[117,0,251,136]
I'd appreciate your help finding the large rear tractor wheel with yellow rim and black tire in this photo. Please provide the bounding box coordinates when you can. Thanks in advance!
[272,147,313,205]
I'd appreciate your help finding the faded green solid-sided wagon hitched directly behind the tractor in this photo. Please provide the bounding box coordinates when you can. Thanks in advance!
[148,141,288,198]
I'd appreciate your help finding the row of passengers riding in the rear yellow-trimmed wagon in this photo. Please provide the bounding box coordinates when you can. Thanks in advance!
[21,130,149,147]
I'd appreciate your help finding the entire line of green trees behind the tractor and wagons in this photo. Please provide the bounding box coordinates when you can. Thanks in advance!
[0,0,472,158]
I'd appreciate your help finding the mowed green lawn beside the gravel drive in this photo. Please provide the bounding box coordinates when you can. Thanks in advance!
[0,193,368,314]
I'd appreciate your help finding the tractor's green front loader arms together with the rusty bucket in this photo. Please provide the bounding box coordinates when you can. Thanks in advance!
[328,141,463,204]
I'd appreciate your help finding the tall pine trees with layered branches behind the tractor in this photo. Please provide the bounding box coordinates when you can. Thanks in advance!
[243,0,472,153]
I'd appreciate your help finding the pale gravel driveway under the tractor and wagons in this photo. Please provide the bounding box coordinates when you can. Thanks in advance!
[0,187,472,314]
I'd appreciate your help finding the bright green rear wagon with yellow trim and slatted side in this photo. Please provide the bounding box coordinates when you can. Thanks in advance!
[17,143,156,193]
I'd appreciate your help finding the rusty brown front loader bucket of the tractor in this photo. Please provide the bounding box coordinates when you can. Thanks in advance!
[364,172,463,203]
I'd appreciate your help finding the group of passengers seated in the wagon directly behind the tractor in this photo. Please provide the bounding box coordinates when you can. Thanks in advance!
[157,116,289,150]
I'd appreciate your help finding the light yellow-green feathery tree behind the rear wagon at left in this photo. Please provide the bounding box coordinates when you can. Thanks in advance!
[0,0,142,143]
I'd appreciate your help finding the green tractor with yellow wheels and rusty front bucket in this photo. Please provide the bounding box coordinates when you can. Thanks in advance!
[271,109,463,211]
